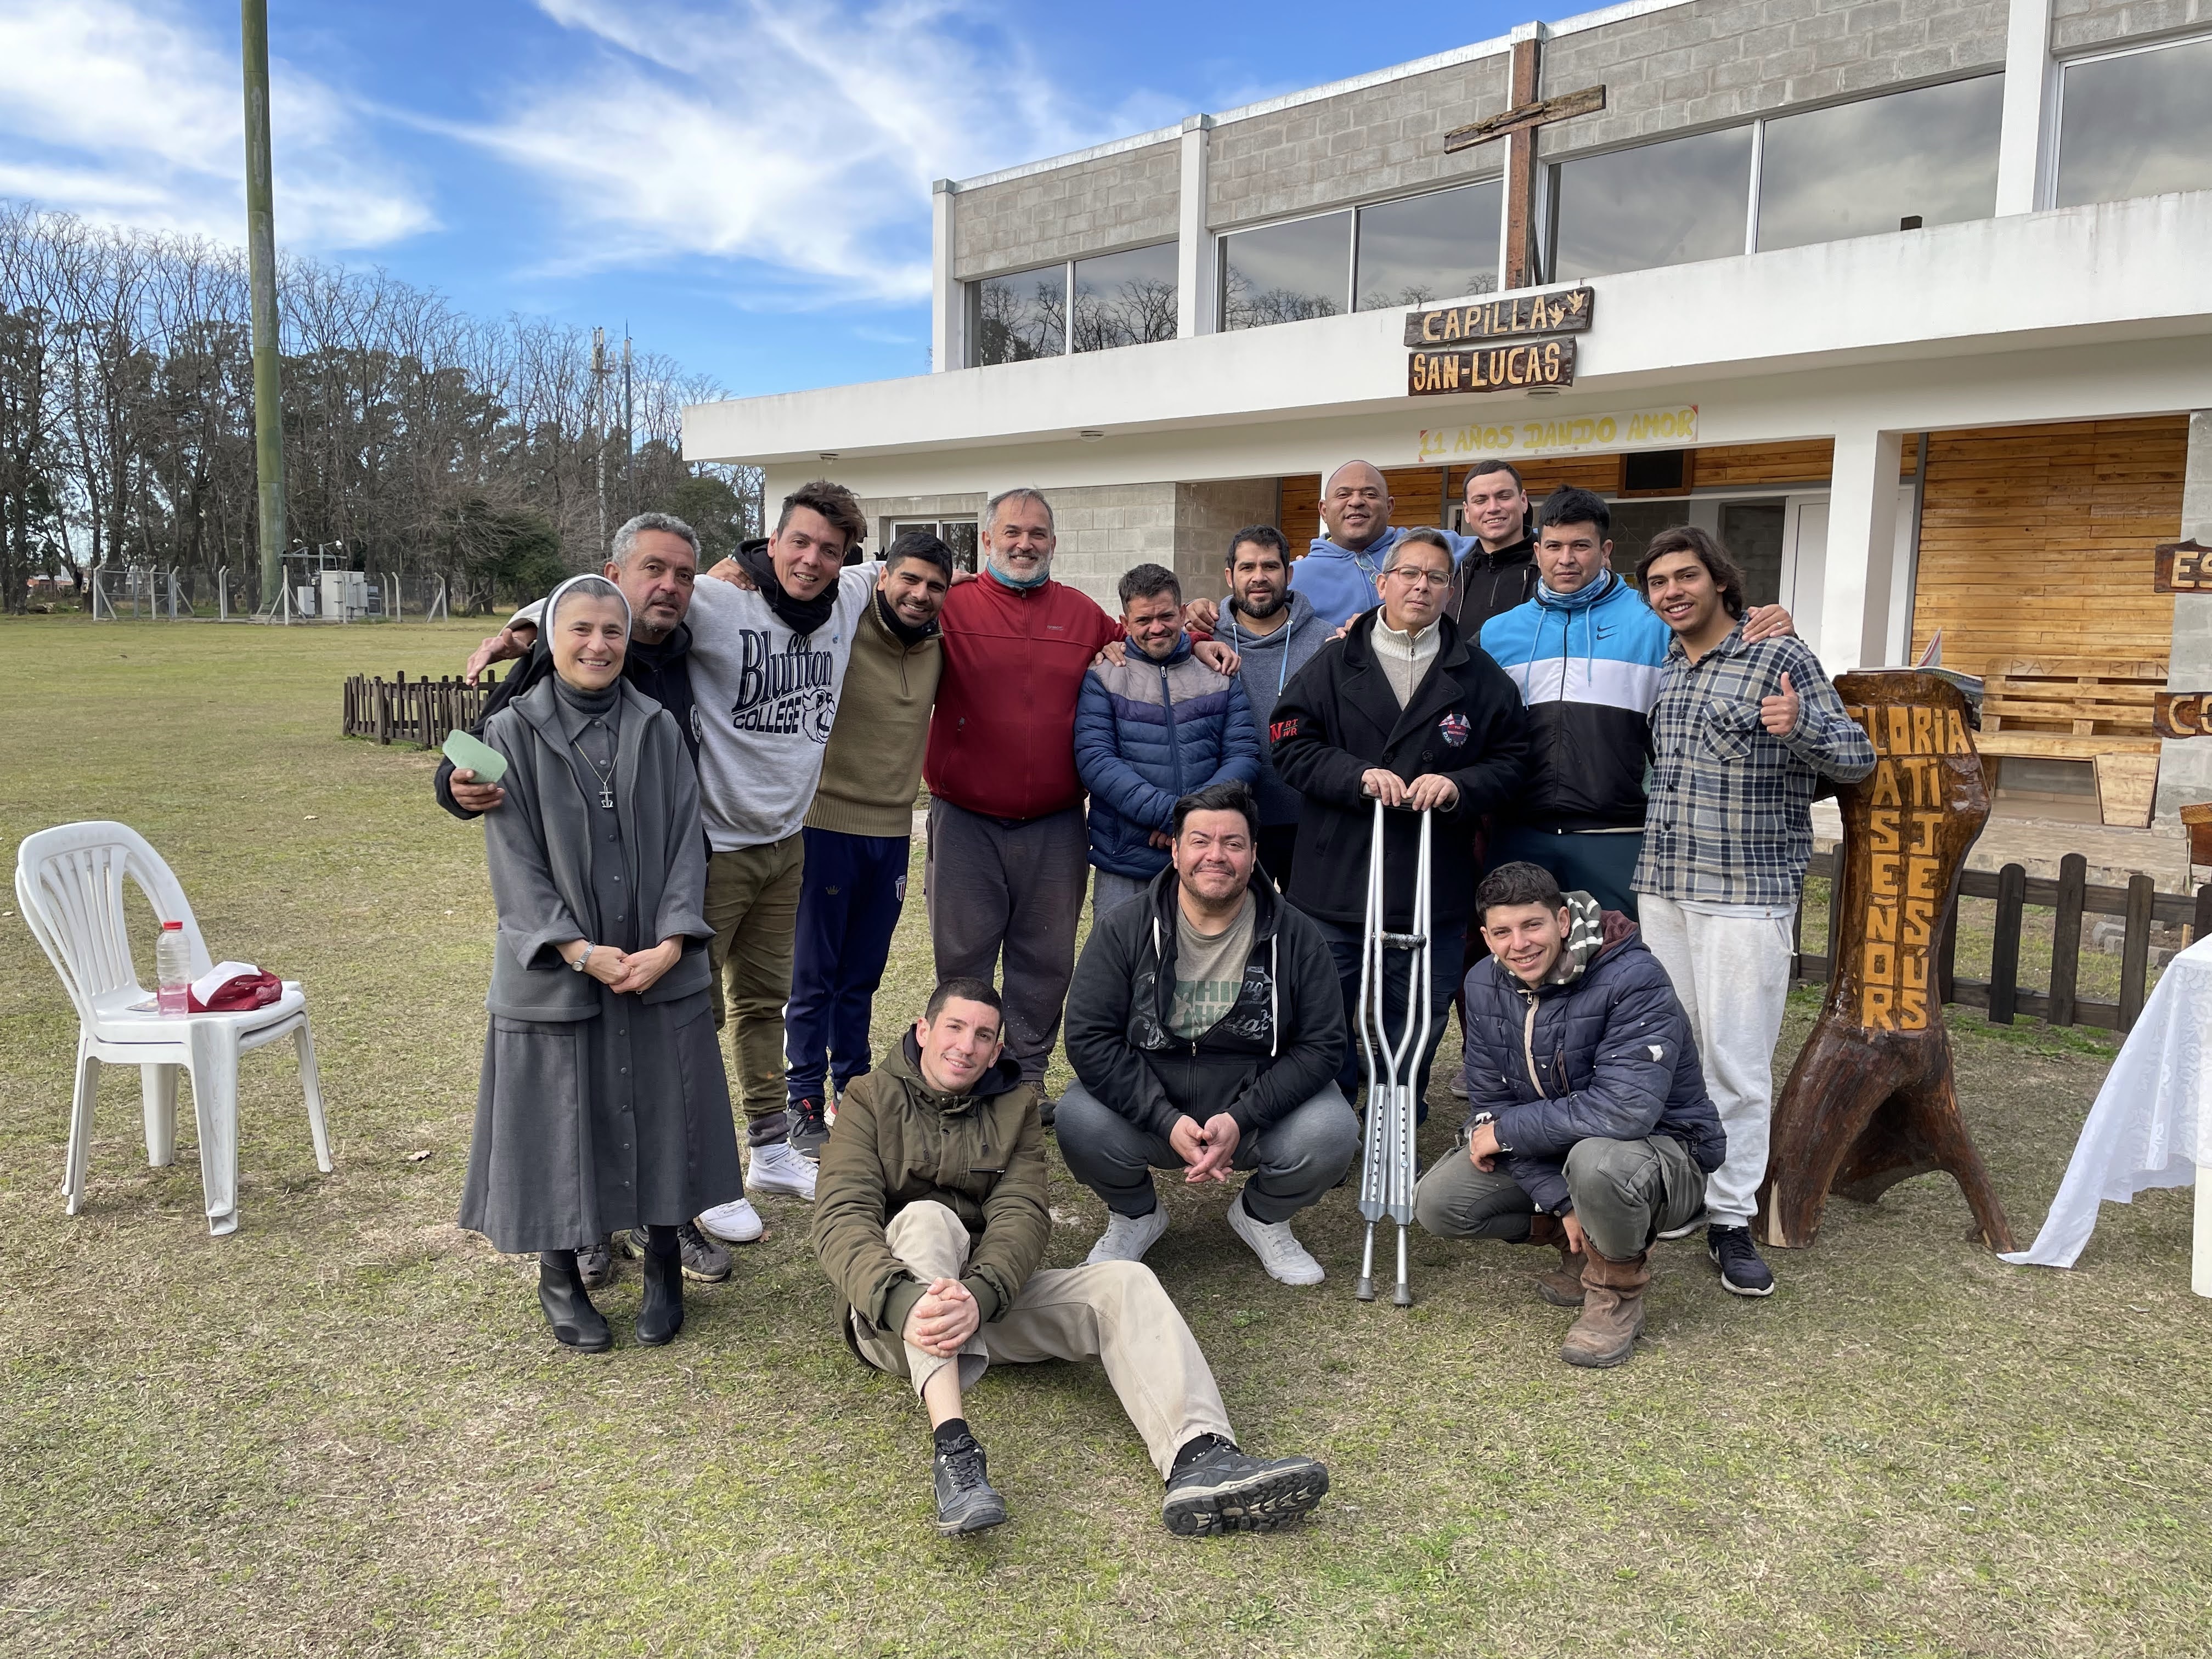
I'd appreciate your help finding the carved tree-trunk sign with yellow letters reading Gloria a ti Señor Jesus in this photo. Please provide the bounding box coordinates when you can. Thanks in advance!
[1758,668,2013,1250]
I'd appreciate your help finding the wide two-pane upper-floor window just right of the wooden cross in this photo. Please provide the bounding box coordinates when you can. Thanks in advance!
[1546,73,2004,281]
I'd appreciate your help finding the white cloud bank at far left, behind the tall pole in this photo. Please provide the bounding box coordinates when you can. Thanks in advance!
[0,0,431,248]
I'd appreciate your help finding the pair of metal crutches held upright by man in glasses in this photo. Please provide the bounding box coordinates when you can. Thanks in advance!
[1352,801,1429,1307]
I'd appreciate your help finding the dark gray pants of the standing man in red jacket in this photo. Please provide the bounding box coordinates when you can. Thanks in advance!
[922,801,1091,1088]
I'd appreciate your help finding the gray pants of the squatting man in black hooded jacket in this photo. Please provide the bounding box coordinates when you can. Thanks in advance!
[1055,1084,1361,1223]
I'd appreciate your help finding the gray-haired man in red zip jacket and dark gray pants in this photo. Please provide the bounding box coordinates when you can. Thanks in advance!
[922,489,1237,1124]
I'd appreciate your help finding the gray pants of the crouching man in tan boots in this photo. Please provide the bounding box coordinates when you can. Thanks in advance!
[1413,1135,1706,1261]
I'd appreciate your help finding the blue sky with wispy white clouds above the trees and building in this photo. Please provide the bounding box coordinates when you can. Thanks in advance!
[0,0,1539,394]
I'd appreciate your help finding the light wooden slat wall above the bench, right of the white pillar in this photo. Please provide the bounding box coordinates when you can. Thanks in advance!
[1914,416,2188,675]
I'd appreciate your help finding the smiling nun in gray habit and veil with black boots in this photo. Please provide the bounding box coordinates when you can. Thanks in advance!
[460,575,743,1354]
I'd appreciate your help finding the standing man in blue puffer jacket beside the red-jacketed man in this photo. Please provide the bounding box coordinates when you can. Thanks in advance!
[1075,564,1259,922]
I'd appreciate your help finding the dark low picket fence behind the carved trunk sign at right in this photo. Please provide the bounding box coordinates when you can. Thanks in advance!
[1792,851,2212,1031]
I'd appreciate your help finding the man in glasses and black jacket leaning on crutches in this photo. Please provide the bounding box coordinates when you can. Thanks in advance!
[1267,529,1528,1115]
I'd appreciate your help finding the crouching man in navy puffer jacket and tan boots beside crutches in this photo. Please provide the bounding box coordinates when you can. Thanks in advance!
[1413,862,1728,1367]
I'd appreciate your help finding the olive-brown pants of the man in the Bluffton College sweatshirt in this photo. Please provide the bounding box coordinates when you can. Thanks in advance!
[703,836,805,1146]
